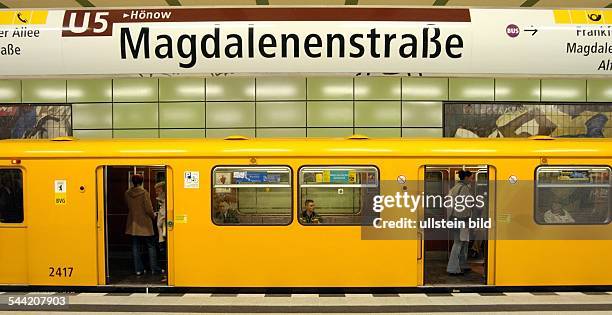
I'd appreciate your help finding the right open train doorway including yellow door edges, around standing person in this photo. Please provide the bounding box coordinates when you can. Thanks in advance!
[417,165,495,286]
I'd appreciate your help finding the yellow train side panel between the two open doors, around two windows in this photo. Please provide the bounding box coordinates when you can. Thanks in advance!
[173,158,417,287]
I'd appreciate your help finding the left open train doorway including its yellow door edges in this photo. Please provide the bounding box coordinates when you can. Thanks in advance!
[96,165,174,286]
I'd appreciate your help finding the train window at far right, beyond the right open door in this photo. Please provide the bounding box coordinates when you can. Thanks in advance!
[535,166,612,224]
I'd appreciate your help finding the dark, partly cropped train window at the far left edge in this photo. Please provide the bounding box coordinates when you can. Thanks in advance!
[0,169,23,223]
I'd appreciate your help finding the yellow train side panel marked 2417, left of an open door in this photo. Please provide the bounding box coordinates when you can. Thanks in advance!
[24,159,97,285]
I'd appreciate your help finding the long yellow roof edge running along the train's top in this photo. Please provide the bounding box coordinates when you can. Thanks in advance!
[0,137,612,159]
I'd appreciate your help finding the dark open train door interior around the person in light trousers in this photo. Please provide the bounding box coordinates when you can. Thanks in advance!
[419,165,492,286]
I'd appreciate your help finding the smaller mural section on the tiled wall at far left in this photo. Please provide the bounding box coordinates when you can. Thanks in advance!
[0,105,72,139]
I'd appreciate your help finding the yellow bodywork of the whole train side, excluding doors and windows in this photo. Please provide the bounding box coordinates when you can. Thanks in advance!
[0,140,612,287]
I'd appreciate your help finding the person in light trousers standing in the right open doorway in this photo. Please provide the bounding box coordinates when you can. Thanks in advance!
[446,170,475,276]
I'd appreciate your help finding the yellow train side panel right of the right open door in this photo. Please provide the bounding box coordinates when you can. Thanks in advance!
[492,158,612,286]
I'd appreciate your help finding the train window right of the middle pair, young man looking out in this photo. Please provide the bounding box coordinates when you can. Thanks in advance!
[299,166,380,225]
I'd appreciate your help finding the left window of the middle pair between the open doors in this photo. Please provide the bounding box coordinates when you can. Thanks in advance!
[212,166,293,225]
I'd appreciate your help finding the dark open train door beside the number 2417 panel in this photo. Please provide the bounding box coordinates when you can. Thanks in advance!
[98,165,172,285]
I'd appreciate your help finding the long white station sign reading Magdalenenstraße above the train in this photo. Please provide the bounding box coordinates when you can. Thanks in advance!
[0,7,612,76]
